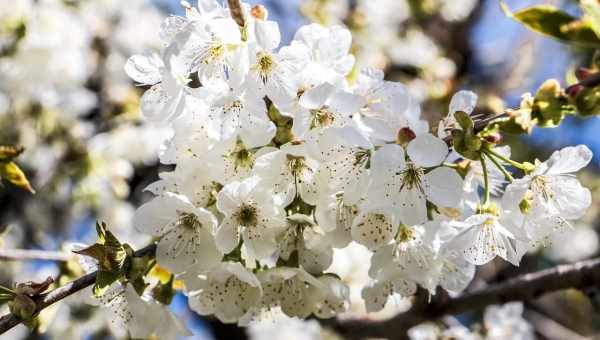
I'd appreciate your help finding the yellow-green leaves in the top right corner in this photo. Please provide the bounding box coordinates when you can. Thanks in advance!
[500,1,600,48]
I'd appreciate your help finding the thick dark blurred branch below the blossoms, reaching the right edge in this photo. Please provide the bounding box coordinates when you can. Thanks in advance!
[323,258,600,339]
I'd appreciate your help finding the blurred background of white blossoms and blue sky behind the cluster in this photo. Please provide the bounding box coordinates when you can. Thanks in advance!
[0,0,600,339]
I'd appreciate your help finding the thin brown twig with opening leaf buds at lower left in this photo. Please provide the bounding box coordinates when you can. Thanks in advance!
[0,243,156,334]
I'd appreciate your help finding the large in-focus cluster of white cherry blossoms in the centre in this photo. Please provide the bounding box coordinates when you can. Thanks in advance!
[118,0,592,327]
